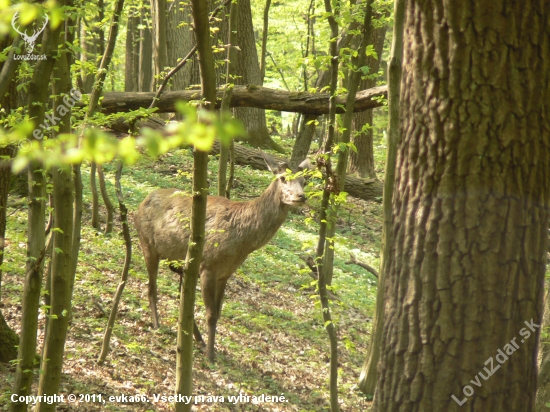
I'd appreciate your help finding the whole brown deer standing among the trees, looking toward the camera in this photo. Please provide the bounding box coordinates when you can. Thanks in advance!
[134,156,308,361]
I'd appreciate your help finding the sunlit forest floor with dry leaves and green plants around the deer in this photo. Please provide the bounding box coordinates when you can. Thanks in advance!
[0,141,382,412]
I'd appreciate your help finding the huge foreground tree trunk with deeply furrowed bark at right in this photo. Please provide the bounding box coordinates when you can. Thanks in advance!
[373,0,550,412]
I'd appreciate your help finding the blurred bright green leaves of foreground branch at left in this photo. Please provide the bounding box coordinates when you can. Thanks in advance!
[0,104,244,173]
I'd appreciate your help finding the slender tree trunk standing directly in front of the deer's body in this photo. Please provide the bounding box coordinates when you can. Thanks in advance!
[176,0,216,412]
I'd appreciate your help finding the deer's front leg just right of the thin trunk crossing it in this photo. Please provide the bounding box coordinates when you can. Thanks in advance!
[201,272,227,362]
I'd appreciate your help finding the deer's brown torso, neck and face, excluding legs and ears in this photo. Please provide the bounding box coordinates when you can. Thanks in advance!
[134,177,305,276]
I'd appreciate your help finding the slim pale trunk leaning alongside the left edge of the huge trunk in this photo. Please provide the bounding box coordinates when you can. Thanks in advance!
[359,0,406,395]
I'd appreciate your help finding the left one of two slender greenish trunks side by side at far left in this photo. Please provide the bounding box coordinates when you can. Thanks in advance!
[10,0,66,411]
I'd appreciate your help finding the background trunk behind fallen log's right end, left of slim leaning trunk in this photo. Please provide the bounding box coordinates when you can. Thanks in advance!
[349,26,386,178]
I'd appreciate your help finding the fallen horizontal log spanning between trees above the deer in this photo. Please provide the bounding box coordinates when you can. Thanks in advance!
[97,85,386,116]
